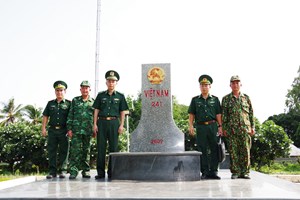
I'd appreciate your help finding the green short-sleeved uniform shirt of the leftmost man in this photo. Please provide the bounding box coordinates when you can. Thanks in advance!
[43,99,71,127]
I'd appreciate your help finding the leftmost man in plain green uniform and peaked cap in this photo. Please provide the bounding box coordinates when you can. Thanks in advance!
[42,81,71,179]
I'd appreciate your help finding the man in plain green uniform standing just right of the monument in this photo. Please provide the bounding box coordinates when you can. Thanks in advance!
[188,75,222,179]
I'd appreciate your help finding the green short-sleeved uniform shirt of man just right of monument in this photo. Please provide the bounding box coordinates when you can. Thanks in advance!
[188,94,221,122]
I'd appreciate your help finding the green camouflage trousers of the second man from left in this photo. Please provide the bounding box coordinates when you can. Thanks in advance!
[69,133,91,175]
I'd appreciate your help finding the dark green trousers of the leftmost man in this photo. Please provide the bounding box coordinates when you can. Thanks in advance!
[47,128,69,174]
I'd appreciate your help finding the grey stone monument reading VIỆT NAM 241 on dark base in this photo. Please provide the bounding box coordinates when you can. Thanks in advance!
[110,63,201,181]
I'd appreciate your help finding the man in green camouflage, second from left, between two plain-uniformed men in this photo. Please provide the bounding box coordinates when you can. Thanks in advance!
[67,81,94,179]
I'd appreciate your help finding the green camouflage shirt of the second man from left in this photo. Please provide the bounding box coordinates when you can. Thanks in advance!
[67,96,94,135]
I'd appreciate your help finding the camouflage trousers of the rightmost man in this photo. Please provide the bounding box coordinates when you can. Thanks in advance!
[228,131,251,175]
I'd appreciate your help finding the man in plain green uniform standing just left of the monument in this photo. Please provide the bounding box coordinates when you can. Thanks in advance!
[93,70,128,179]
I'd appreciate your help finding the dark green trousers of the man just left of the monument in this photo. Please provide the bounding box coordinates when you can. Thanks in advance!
[97,119,120,176]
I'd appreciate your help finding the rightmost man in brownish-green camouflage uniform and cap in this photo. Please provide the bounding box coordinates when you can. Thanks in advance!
[222,76,255,179]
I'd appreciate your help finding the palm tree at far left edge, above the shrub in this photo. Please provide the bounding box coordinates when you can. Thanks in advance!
[0,98,23,125]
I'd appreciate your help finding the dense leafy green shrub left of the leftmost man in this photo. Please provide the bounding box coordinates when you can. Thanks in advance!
[0,122,48,173]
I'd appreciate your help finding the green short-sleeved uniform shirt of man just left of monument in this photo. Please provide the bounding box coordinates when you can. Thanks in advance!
[93,91,128,117]
